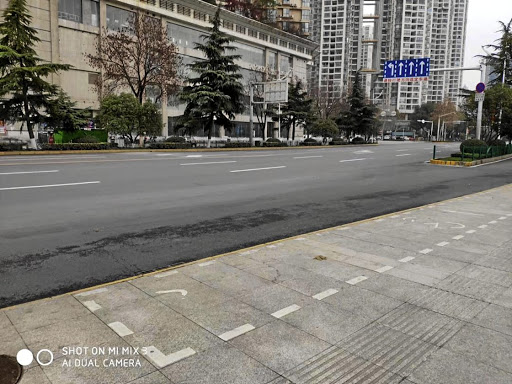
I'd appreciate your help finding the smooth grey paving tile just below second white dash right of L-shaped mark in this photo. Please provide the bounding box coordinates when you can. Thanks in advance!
[229,320,330,374]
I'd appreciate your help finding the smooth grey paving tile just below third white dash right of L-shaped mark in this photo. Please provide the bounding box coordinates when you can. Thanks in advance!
[282,302,371,344]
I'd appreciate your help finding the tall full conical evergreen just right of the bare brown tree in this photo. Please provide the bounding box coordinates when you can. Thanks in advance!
[180,7,244,147]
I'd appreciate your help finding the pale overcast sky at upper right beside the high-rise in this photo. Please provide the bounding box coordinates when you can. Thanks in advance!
[462,0,512,89]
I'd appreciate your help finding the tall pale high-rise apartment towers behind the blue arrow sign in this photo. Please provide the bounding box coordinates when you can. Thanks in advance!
[311,0,468,113]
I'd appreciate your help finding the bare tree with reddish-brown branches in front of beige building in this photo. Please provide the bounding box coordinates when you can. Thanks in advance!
[86,11,181,104]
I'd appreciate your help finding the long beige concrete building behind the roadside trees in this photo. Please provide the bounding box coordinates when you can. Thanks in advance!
[0,0,316,136]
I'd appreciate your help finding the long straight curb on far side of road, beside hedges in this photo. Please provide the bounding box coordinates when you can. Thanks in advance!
[0,144,379,157]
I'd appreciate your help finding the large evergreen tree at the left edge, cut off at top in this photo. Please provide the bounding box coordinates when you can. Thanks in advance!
[0,0,70,148]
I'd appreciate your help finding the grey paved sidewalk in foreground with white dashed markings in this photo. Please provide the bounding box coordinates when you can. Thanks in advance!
[0,186,512,384]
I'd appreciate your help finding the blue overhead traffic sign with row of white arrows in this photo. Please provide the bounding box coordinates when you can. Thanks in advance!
[384,57,430,83]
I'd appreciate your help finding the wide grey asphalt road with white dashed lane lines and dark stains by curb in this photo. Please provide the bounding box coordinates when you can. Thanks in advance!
[0,142,512,307]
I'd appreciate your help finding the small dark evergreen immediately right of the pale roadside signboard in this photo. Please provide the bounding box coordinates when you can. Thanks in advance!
[281,81,314,140]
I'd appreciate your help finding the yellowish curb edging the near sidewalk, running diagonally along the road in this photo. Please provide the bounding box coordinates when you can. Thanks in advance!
[0,184,512,312]
